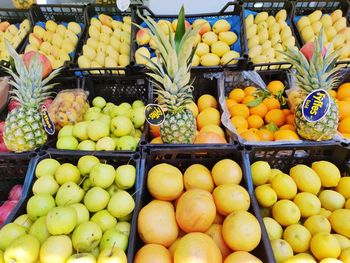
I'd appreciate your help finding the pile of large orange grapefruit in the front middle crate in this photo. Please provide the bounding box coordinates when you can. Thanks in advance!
[134,159,262,263]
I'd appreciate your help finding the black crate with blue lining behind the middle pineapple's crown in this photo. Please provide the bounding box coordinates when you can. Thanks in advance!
[131,2,247,72]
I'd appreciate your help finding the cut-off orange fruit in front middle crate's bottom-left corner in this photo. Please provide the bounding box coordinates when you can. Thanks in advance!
[134,244,173,263]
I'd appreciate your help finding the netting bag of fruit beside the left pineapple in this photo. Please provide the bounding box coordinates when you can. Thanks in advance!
[48,89,89,130]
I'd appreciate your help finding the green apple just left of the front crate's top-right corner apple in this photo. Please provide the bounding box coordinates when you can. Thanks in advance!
[90,163,115,189]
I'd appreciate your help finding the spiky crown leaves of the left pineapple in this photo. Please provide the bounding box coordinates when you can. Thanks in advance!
[4,41,61,107]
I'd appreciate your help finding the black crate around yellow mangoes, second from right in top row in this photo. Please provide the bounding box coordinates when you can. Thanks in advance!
[242,0,299,70]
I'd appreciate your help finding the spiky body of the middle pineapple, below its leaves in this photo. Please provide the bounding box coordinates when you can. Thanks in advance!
[160,109,196,144]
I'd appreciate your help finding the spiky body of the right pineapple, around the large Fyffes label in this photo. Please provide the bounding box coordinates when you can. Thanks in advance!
[295,98,339,141]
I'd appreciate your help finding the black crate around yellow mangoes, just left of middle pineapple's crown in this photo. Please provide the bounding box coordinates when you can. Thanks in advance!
[72,1,136,76]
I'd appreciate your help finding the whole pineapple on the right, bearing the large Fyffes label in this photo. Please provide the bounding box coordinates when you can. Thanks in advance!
[281,30,339,141]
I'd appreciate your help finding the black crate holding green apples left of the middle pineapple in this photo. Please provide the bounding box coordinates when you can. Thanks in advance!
[43,75,152,154]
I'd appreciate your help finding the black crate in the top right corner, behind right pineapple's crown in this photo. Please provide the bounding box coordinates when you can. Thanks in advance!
[292,0,350,68]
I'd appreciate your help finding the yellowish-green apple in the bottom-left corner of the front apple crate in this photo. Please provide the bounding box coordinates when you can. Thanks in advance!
[4,235,40,263]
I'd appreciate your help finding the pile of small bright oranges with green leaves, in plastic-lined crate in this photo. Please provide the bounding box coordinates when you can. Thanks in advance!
[226,80,299,142]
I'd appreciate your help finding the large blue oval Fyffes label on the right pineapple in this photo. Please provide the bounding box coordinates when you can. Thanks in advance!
[302,89,330,122]
